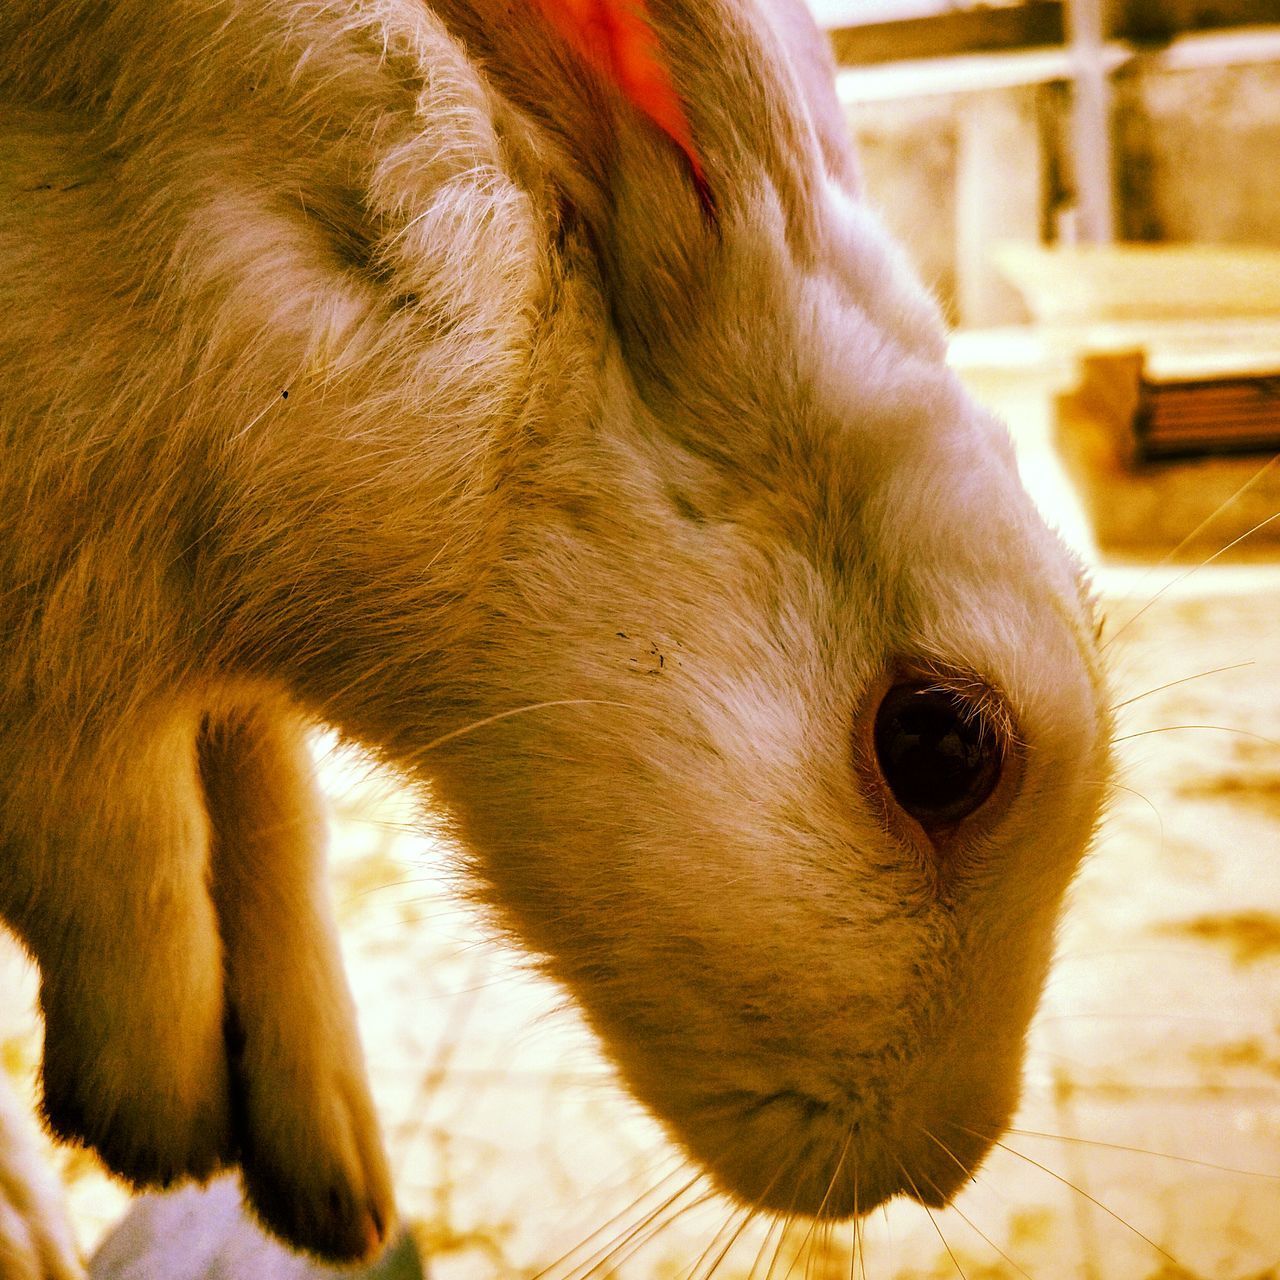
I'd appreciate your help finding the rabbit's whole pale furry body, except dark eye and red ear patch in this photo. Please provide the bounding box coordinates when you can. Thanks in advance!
[0,0,1107,1257]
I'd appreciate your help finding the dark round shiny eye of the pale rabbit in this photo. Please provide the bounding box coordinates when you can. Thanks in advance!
[874,681,1005,831]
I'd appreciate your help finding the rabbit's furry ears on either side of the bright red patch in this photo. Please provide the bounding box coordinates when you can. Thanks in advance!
[433,0,849,356]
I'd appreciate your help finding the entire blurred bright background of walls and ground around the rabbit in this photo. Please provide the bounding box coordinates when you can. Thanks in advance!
[0,0,1280,1280]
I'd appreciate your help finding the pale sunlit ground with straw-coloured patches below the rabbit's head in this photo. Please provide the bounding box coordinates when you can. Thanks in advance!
[3,350,1280,1280]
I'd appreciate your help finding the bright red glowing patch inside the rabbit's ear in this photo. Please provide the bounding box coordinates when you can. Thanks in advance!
[534,0,716,215]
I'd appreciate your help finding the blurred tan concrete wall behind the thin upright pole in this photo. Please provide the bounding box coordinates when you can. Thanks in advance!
[849,56,1280,325]
